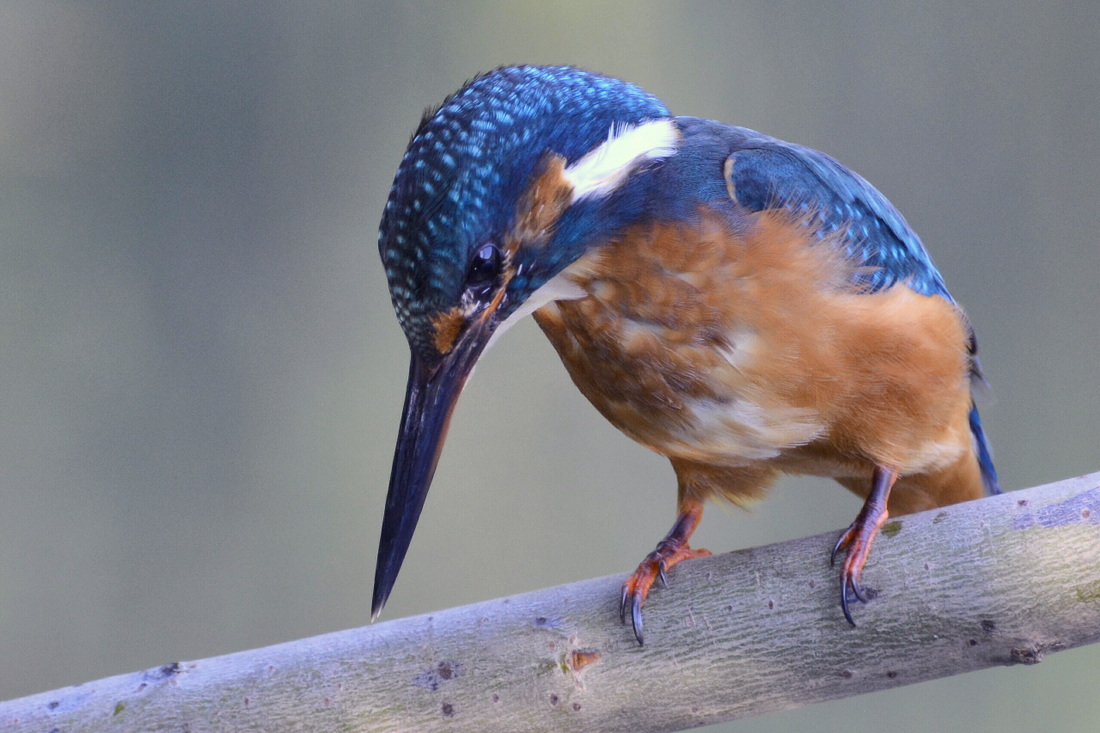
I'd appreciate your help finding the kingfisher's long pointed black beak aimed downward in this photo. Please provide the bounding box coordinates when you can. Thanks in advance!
[371,313,493,621]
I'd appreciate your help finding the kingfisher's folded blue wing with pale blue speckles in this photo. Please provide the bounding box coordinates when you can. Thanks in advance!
[729,128,952,300]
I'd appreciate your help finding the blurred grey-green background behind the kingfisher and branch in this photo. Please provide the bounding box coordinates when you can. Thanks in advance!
[0,0,1100,733]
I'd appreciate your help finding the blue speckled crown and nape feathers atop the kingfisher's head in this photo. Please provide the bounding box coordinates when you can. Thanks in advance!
[378,66,669,353]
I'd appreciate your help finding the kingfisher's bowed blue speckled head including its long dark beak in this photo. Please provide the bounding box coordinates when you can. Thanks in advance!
[372,66,679,617]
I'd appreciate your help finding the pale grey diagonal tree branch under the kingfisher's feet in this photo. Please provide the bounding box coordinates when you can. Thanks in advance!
[0,473,1100,733]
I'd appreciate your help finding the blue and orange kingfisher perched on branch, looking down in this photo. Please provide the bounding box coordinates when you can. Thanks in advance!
[372,66,1000,644]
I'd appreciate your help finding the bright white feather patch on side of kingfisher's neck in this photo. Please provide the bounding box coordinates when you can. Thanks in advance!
[564,119,680,203]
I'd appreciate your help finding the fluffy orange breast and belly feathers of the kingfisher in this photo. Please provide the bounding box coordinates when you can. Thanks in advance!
[536,214,968,474]
